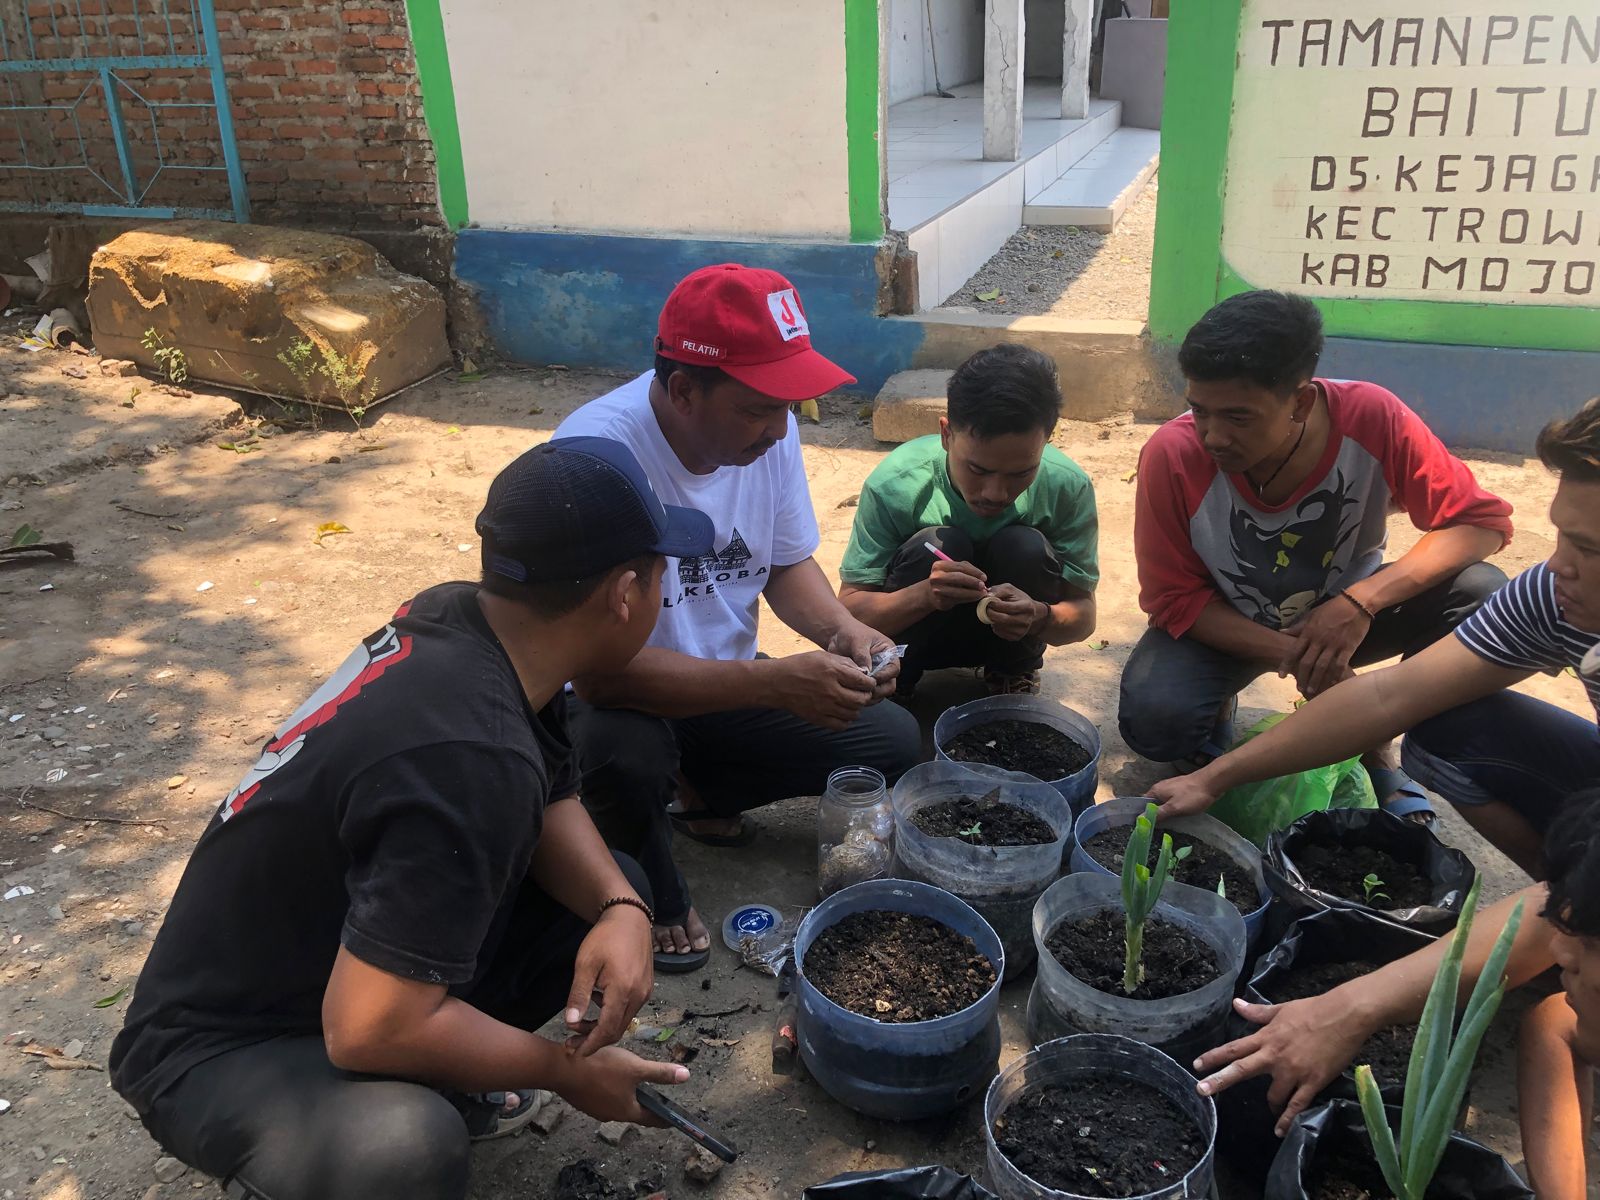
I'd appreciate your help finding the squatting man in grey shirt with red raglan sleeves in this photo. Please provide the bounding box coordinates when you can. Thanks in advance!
[1118,291,1512,814]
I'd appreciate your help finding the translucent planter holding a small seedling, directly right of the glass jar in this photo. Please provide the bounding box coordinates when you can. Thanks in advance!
[894,762,1072,979]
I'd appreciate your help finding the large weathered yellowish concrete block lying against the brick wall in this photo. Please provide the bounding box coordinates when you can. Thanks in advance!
[88,221,450,408]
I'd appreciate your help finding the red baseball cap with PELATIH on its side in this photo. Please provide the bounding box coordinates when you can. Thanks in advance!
[656,262,856,402]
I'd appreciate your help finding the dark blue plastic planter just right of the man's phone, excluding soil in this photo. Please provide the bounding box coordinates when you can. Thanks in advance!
[795,880,1005,1120]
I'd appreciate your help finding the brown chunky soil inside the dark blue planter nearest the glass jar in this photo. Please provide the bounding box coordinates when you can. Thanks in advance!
[803,910,995,1022]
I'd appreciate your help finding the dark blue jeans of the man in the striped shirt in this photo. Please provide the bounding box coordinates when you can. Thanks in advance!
[1400,691,1600,834]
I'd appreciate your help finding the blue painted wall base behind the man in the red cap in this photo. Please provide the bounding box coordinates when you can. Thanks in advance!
[456,229,923,392]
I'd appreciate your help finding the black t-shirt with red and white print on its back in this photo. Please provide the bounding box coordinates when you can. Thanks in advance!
[110,584,578,1110]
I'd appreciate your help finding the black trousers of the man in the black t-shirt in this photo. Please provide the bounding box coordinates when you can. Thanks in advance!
[144,856,650,1200]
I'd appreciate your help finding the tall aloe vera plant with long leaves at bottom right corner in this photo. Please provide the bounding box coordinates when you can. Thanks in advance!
[1355,880,1522,1200]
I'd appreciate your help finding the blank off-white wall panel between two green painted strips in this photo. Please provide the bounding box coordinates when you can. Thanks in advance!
[442,0,857,240]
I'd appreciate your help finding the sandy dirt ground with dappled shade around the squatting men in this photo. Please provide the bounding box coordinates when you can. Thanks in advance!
[0,350,1587,1200]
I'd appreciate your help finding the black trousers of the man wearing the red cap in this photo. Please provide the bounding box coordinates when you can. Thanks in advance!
[568,684,922,922]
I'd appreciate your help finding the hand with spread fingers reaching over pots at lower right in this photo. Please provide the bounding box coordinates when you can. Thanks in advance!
[1195,989,1376,1138]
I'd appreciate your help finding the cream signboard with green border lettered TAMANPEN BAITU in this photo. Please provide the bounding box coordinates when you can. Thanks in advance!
[1150,0,1600,350]
